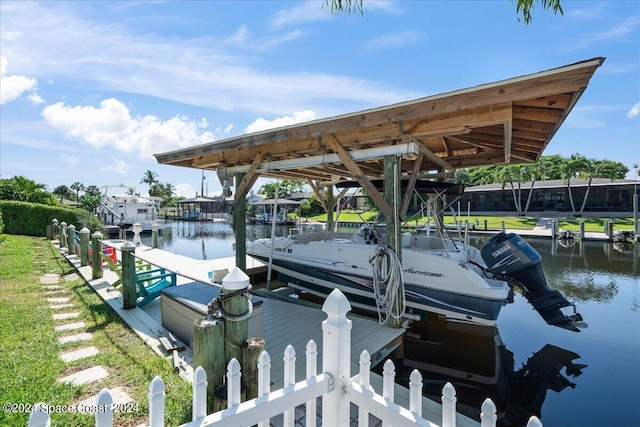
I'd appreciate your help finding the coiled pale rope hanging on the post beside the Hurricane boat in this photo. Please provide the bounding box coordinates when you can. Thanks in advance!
[369,245,406,324]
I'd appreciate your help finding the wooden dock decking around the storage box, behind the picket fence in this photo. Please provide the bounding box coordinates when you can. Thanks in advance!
[63,240,479,427]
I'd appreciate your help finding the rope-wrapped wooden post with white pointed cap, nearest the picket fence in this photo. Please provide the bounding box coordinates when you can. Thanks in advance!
[222,267,250,366]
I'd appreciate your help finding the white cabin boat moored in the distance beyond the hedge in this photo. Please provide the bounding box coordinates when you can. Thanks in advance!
[96,185,164,232]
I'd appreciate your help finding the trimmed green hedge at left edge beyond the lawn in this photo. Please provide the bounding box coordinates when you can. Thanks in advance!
[0,200,104,237]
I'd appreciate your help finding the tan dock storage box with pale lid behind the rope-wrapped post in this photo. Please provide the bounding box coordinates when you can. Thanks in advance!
[160,282,264,347]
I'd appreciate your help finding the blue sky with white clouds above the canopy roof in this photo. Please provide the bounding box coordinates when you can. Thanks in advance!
[0,0,640,197]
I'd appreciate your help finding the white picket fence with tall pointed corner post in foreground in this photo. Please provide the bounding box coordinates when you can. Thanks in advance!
[29,290,542,427]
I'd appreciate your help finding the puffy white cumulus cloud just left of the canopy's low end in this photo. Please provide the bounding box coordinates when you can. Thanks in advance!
[42,98,215,158]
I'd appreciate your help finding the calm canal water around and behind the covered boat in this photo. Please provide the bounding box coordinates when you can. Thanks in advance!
[143,222,640,427]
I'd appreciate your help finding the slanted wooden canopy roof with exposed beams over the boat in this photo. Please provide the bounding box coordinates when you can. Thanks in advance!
[155,57,604,202]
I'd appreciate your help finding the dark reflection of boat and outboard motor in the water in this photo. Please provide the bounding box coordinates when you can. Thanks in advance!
[394,320,587,426]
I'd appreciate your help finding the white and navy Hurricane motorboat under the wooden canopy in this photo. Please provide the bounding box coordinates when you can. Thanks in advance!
[247,183,582,331]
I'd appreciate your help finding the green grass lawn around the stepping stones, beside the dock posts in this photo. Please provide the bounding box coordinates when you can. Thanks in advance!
[0,235,191,426]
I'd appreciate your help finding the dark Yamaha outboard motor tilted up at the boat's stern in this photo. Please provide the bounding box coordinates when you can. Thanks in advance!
[480,233,582,332]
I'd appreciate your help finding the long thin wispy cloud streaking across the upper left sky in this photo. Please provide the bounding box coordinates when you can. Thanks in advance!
[2,1,418,116]
